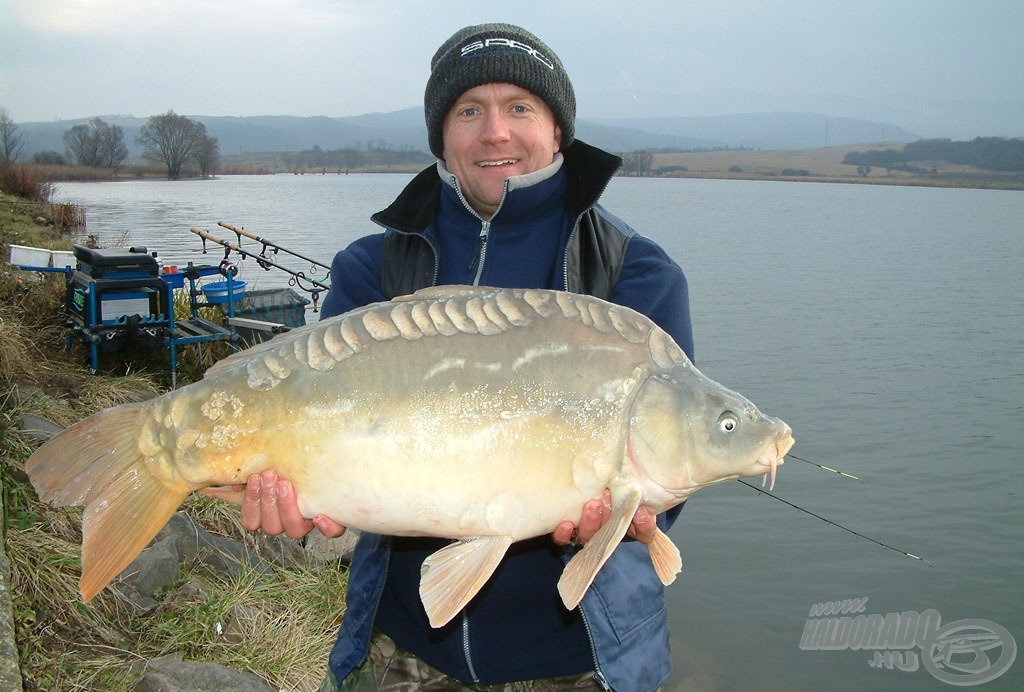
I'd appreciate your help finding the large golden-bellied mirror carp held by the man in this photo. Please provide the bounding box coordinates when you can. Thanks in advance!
[27,287,793,626]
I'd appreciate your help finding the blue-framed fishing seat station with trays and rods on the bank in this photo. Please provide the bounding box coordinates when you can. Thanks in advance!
[10,222,330,386]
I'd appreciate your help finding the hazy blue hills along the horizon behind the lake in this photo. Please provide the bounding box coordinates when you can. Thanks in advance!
[18,107,919,159]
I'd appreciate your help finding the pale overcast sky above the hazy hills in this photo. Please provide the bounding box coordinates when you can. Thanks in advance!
[0,0,1024,138]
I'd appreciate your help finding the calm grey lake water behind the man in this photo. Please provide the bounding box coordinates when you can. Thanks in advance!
[56,175,1024,691]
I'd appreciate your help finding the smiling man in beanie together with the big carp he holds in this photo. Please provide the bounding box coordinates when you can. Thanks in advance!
[26,18,794,691]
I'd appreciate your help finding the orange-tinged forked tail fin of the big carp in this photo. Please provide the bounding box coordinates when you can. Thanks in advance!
[26,402,193,601]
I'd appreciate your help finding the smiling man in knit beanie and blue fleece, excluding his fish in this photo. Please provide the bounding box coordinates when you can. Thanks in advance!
[243,24,693,690]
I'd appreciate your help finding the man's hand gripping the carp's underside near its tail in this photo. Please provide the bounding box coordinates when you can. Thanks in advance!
[203,469,345,538]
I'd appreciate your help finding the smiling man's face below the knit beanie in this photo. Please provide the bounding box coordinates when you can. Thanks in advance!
[442,84,562,219]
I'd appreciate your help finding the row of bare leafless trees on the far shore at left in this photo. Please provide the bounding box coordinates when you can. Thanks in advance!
[0,106,220,180]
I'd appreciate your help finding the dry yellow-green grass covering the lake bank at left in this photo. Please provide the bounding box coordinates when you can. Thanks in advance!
[0,189,347,692]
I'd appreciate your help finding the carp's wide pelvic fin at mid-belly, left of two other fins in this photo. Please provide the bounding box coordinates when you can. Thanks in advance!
[420,535,513,628]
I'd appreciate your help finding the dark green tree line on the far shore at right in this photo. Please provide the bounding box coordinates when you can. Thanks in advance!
[843,137,1024,173]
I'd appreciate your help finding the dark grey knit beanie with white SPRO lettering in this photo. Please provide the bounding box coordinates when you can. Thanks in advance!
[423,24,575,159]
